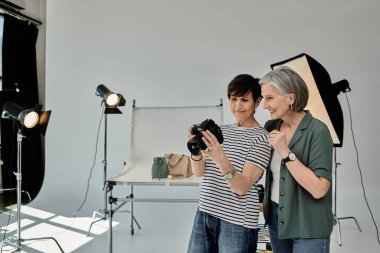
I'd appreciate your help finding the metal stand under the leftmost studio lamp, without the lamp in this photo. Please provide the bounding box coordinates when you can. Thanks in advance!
[4,128,64,252]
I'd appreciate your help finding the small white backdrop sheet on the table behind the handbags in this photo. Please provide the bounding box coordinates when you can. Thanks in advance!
[112,102,223,183]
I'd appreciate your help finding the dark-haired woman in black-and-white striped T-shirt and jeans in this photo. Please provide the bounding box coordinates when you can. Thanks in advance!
[187,74,270,253]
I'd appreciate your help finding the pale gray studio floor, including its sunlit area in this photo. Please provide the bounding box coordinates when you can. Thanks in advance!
[0,203,380,253]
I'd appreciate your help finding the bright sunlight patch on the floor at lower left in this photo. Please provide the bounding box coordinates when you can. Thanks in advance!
[0,206,119,253]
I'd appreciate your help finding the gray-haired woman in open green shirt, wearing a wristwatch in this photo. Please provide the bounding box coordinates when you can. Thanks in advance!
[259,66,333,253]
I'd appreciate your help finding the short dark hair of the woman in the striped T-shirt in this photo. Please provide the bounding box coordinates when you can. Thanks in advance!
[227,74,261,101]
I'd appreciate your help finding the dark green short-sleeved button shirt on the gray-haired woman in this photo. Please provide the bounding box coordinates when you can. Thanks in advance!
[264,111,333,239]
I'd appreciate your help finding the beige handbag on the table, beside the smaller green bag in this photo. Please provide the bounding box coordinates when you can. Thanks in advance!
[165,153,193,178]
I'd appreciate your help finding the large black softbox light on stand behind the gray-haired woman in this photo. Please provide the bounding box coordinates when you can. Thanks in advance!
[271,54,362,246]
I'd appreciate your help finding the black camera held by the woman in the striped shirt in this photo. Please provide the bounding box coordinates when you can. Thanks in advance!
[187,119,223,155]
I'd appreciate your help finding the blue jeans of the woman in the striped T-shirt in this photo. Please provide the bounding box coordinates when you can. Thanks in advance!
[187,210,258,253]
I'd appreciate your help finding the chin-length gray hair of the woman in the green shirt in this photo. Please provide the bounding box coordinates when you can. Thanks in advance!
[259,66,309,112]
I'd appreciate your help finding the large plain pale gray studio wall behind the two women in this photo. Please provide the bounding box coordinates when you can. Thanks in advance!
[31,0,380,241]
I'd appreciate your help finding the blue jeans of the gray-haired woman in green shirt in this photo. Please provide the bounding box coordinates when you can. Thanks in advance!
[268,201,330,253]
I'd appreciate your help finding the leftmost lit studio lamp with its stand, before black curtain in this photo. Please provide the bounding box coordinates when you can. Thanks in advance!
[1,101,63,252]
